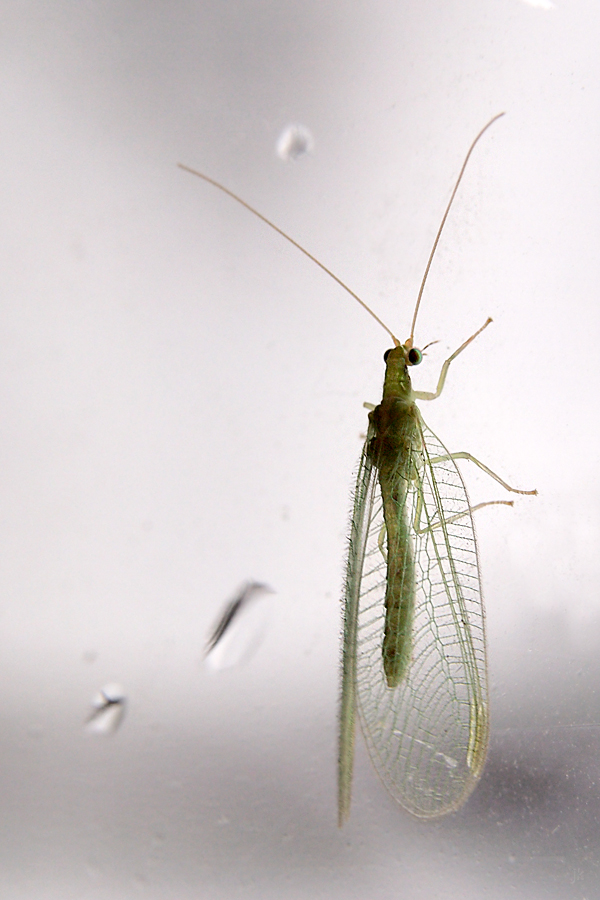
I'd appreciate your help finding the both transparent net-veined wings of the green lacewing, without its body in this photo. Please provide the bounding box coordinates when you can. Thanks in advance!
[340,423,489,819]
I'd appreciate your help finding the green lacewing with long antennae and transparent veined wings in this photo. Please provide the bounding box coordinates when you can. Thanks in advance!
[180,113,537,825]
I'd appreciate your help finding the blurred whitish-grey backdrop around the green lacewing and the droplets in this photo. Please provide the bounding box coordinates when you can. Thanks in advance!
[0,0,600,900]
